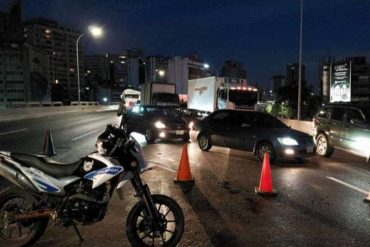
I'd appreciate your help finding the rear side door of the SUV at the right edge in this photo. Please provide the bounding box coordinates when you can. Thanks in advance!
[328,107,346,148]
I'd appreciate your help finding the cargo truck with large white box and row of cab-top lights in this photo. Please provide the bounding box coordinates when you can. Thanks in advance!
[187,76,258,112]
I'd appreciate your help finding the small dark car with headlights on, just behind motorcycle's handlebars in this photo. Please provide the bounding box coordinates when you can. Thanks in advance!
[122,105,189,143]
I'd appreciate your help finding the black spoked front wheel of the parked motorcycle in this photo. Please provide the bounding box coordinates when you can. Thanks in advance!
[126,195,185,246]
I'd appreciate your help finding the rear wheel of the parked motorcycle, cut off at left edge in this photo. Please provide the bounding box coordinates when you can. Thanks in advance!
[0,187,49,246]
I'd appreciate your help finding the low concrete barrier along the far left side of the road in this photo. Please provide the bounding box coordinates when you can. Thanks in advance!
[0,104,118,122]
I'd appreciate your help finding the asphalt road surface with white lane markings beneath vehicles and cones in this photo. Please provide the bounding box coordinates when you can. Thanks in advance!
[0,112,370,246]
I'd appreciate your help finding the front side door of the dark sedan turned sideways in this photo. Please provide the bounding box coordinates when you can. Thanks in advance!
[225,111,254,151]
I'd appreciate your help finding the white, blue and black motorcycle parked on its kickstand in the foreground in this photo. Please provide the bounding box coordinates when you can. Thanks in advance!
[0,125,185,246]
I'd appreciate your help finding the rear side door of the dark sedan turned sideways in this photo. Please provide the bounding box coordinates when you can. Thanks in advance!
[209,111,230,146]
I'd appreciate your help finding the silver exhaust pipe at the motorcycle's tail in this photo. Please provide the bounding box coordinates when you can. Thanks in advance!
[0,157,38,192]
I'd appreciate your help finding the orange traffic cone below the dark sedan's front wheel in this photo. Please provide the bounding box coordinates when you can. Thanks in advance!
[254,152,277,196]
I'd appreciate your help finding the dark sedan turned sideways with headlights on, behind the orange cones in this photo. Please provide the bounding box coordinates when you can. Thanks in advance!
[195,110,316,162]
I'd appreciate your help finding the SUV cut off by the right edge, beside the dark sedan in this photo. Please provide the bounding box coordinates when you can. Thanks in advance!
[312,103,370,161]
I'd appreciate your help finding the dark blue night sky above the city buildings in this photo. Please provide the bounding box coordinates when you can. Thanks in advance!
[0,0,370,88]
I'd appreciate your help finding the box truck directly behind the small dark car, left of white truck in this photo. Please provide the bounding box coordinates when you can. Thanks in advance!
[140,82,180,106]
